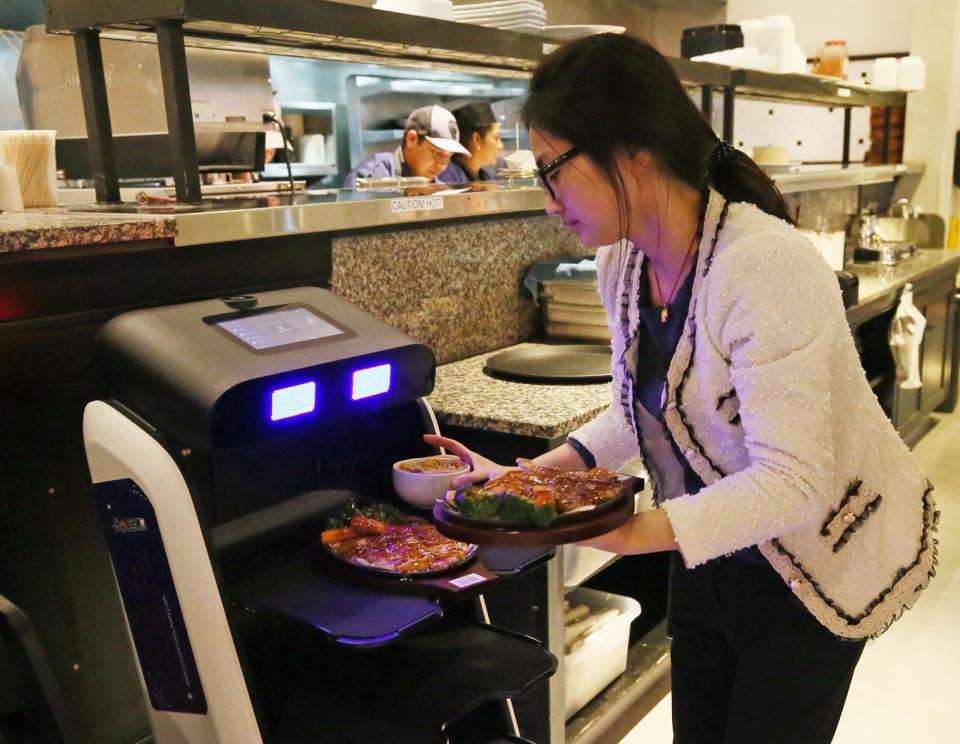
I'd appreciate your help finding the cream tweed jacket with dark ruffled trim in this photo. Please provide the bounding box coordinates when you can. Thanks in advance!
[571,191,939,638]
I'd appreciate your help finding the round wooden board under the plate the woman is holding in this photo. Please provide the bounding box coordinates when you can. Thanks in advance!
[433,493,634,545]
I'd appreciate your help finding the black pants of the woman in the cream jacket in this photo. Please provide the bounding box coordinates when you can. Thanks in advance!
[668,554,864,744]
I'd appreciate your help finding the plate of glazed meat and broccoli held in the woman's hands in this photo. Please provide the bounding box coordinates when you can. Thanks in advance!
[433,460,642,544]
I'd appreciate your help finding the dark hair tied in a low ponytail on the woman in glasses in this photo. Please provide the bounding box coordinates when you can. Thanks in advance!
[522,34,794,226]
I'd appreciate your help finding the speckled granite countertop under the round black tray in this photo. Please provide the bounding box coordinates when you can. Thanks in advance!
[428,343,610,439]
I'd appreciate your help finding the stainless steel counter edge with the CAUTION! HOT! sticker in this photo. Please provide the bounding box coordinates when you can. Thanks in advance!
[175,186,546,246]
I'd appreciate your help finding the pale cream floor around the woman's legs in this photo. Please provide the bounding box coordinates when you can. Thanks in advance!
[620,408,960,744]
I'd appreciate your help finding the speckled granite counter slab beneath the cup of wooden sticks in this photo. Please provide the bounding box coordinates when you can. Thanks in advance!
[0,210,177,254]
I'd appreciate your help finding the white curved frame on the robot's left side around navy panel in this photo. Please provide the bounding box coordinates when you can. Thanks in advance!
[83,401,263,744]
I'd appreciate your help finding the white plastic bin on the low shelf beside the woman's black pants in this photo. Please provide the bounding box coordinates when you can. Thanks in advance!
[563,587,640,719]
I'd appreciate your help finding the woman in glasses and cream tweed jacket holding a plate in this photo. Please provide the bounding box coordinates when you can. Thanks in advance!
[428,34,938,744]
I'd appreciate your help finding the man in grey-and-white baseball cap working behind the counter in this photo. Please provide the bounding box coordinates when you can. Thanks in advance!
[343,106,470,188]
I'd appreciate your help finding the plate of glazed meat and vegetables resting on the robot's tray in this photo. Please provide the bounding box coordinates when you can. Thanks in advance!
[319,502,477,579]
